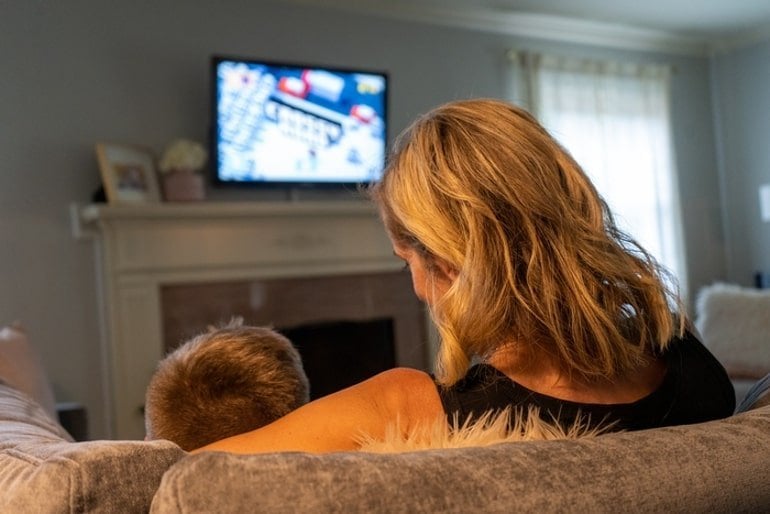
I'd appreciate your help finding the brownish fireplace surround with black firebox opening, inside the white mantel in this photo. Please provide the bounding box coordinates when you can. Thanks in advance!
[161,271,427,398]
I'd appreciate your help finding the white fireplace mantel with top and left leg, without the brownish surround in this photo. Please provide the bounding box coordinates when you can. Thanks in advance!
[77,201,408,439]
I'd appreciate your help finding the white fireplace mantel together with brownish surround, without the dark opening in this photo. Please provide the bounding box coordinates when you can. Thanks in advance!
[76,201,435,439]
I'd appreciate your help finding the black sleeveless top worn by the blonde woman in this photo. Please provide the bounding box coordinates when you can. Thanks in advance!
[437,332,735,430]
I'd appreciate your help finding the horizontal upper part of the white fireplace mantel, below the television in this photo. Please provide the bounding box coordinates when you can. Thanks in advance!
[75,201,397,281]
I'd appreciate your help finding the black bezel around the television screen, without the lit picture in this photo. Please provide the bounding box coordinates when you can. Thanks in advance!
[208,54,390,190]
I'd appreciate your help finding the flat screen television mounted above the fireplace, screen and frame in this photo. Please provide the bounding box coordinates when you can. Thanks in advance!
[210,56,388,188]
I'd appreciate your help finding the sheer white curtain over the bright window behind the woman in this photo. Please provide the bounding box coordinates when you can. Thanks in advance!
[509,52,687,295]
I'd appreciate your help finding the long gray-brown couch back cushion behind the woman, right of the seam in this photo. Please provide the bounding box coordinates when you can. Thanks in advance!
[151,407,770,514]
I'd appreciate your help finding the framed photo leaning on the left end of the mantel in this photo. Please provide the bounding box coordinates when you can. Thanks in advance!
[96,143,160,204]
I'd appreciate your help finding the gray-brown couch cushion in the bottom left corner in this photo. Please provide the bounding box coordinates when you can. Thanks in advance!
[0,384,185,513]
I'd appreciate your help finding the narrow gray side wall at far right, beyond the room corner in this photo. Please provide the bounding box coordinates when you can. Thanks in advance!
[713,41,770,284]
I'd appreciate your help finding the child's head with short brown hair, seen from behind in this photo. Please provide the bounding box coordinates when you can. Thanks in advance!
[145,320,309,450]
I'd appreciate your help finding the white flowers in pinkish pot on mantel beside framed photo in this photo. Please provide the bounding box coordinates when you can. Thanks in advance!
[158,139,207,202]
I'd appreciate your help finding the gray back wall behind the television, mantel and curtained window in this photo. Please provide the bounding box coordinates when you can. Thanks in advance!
[0,0,728,437]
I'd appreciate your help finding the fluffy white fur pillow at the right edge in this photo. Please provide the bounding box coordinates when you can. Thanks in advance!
[695,283,770,379]
